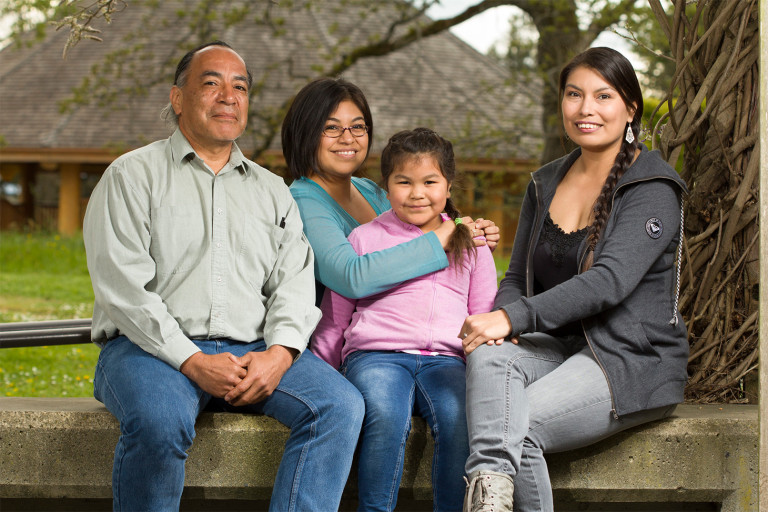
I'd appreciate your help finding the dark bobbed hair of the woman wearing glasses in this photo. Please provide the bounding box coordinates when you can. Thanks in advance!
[281,78,373,179]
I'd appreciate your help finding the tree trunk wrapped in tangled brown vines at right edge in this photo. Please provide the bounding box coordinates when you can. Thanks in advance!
[650,0,759,402]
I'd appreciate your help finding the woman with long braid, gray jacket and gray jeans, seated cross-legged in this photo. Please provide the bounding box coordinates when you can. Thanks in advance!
[459,48,688,511]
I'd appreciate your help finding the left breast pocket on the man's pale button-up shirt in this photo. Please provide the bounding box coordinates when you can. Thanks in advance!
[149,206,208,276]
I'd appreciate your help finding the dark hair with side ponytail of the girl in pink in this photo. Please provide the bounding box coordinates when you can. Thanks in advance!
[381,128,477,269]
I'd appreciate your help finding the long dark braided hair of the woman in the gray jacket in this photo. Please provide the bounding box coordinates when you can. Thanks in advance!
[560,47,643,269]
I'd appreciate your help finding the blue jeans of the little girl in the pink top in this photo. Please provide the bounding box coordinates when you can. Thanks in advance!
[341,351,469,511]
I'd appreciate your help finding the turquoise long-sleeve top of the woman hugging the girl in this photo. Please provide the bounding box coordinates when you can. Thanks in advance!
[291,177,448,299]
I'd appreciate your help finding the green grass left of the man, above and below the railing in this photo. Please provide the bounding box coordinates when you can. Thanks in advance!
[0,231,99,397]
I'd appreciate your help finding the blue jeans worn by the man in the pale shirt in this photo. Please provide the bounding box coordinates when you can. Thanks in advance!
[94,336,364,512]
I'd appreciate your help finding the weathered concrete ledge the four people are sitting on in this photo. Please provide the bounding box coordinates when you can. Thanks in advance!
[0,398,758,512]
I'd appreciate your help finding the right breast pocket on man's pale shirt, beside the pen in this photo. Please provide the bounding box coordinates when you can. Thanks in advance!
[237,219,286,293]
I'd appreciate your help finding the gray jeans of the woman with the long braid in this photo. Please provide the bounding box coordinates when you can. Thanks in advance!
[466,333,675,511]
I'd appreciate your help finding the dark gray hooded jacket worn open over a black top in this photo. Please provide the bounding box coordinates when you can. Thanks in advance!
[494,144,688,416]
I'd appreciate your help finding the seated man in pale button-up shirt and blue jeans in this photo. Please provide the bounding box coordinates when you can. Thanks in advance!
[83,41,364,511]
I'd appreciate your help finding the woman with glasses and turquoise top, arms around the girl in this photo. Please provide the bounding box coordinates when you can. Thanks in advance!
[282,78,499,304]
